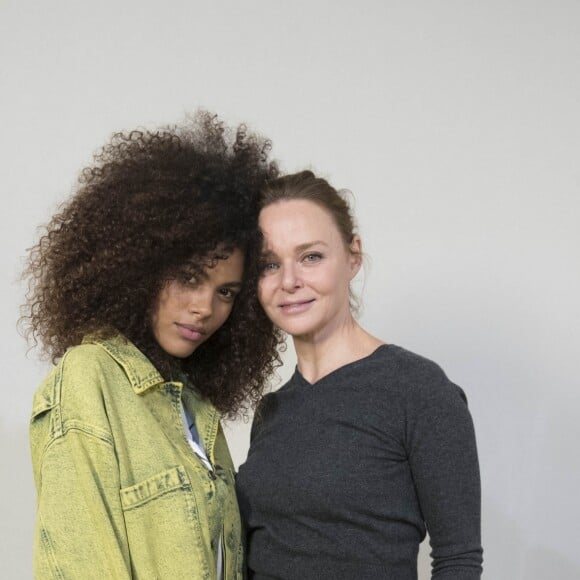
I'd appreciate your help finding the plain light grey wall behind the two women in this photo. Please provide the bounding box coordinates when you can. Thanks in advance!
[0,0,580,580]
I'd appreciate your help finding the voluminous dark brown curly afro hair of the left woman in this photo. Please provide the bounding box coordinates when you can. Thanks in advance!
[21,111,282,417]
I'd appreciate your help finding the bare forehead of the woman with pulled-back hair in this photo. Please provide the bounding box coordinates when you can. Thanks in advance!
[260,199,341,246]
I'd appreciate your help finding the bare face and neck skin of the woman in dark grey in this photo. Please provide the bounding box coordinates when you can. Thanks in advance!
[259,200,383,383]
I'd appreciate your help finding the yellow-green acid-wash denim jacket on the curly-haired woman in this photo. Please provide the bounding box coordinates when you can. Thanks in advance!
[30,336,243,580]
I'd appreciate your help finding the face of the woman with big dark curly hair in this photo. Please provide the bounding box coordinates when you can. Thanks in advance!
[151,250,244,358]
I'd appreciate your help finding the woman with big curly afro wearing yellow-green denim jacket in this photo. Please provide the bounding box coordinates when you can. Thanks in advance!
[22,112,280,580]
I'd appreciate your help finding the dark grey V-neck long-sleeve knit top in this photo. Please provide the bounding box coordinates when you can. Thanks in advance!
[237,345,482,580]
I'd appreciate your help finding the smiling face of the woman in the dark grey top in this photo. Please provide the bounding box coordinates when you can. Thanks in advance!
[259,200,360,340]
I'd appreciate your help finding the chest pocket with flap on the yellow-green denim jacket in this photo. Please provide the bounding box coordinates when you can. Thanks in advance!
[120,465,215,580]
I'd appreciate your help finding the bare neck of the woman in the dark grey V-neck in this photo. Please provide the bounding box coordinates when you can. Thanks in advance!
[293,316,383,383]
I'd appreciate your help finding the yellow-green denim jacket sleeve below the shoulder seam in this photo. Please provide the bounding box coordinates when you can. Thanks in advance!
[34,430,131,579]
